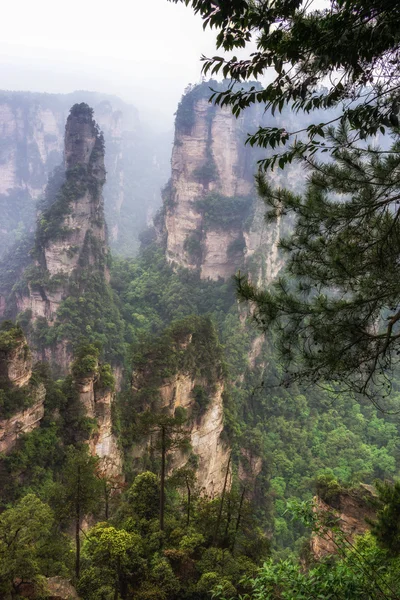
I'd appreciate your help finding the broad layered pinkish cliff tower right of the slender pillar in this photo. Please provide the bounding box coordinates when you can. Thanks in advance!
[164,84,281,280]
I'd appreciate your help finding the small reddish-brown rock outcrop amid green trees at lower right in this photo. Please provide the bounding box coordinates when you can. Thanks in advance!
[310,485,376,560]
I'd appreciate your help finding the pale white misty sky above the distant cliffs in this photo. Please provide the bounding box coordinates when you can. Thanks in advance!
[0,0,222,128]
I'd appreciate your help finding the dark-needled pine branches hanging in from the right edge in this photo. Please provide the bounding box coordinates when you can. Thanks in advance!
[237,126,400,396]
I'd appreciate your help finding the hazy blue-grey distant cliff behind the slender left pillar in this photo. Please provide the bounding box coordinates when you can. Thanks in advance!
[0,91,169,257]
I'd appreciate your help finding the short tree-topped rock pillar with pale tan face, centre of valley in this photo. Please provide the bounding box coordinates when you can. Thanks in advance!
[132,317,230,497]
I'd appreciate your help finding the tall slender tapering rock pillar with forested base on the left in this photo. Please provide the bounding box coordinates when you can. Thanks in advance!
[2,103,122,374]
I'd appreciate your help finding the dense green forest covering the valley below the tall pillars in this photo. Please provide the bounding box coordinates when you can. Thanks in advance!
[1,237,400,599]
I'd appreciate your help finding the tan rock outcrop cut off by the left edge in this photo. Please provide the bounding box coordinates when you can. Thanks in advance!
[0,328,46,453]
